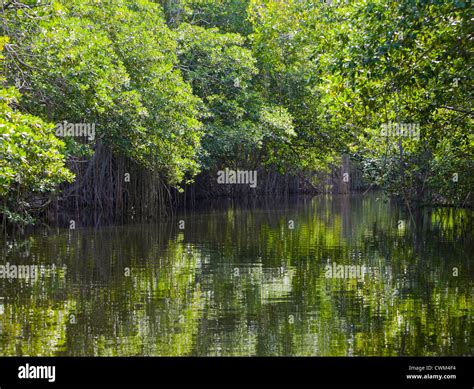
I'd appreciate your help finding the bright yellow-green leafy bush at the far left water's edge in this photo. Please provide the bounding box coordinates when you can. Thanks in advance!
[0,38,73,224]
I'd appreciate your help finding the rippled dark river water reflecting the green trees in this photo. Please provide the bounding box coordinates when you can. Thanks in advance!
[0,194,474,356]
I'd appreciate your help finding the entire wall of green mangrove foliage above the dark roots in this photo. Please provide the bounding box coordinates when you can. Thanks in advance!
[0,0,474,221]
